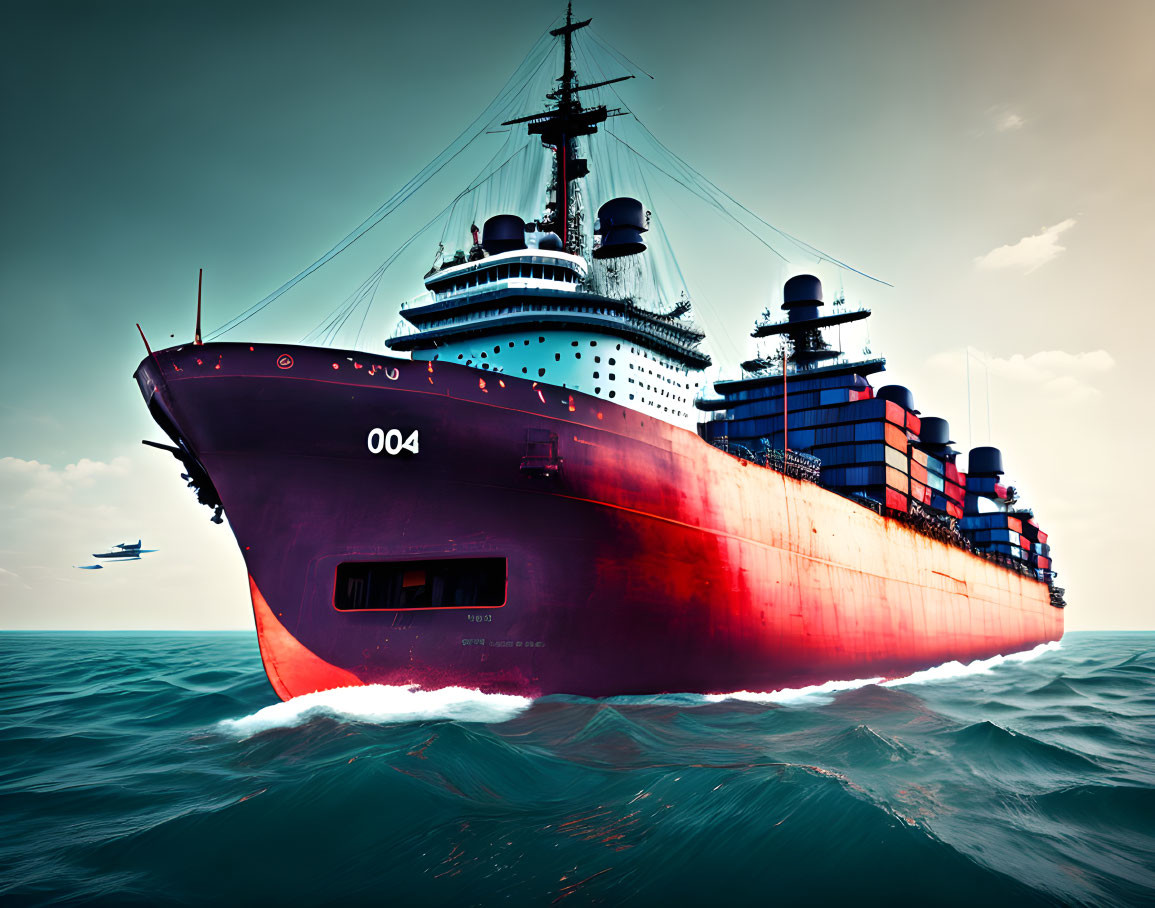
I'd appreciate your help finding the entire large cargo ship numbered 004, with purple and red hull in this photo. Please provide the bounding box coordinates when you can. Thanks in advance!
[135,10,1064,699]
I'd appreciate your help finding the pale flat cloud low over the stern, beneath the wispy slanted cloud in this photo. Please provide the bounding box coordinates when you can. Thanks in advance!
[927,350,1115,401]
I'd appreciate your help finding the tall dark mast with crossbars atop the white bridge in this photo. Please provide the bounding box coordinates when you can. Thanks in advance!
[501,2,633,254]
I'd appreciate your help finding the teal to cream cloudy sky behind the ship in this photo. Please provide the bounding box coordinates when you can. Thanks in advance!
[0,0,1155,630]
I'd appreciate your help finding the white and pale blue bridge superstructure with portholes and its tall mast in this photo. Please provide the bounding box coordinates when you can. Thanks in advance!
[387,8,710,427]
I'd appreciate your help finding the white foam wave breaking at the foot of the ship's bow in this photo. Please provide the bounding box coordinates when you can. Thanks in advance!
[218,684,532,737]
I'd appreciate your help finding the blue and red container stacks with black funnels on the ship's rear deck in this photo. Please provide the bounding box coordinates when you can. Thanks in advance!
[699,275,1055,586]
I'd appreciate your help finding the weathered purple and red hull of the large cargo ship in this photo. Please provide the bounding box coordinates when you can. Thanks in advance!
[136,344,1063,698]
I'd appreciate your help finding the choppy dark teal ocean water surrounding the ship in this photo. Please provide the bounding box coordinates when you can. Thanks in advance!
[0,633,1155,908]
